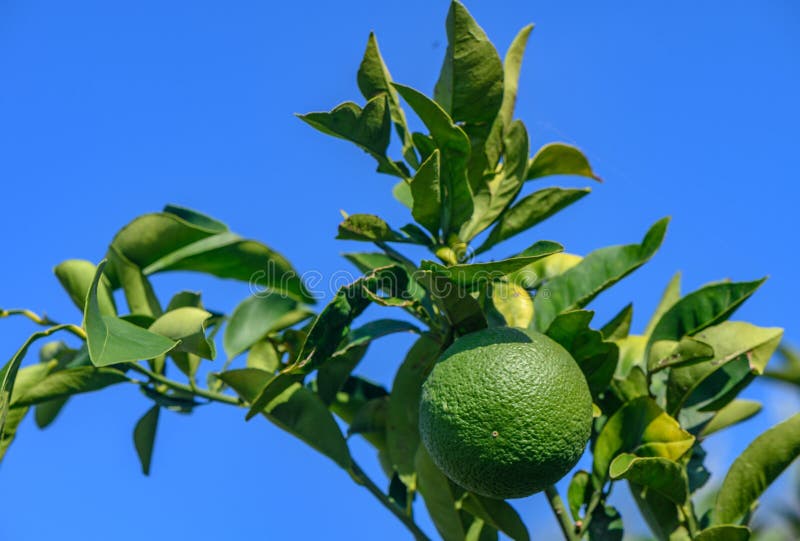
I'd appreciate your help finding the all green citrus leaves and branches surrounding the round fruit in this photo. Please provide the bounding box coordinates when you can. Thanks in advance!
[0,2,800,541]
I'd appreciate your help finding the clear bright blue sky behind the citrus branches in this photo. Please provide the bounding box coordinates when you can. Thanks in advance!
[0,0,800,541]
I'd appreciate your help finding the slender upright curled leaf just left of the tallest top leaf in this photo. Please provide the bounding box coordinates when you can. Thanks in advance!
[357,32,419,167]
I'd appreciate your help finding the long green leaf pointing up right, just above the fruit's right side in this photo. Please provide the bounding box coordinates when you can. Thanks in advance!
[533,218,669,329]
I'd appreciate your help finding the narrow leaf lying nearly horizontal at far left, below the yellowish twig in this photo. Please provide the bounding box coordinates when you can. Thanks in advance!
[11,366,130,407]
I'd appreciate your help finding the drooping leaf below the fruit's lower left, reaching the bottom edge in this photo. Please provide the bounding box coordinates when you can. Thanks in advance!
[416,442,465,541]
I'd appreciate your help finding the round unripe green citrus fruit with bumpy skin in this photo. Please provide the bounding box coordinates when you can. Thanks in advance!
[419,327,592,499]
